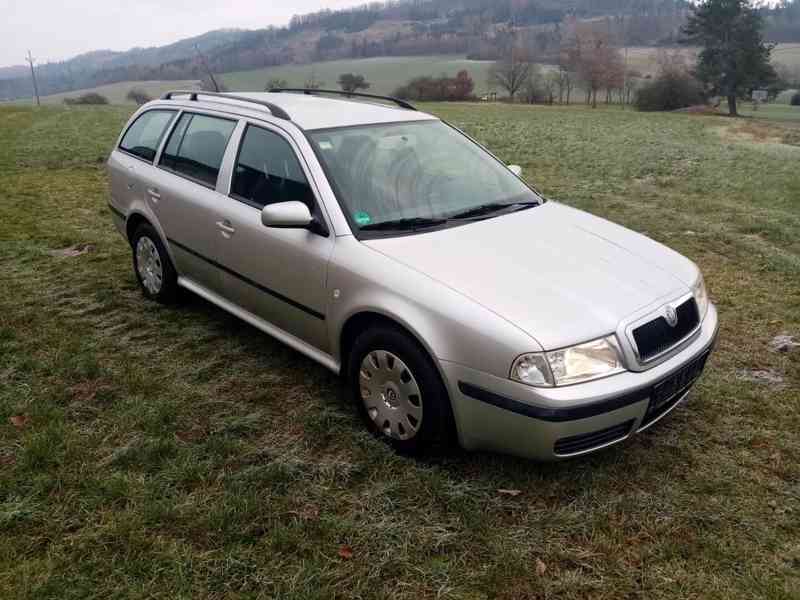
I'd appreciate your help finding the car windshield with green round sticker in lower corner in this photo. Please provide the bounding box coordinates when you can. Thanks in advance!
[310,120,541,231]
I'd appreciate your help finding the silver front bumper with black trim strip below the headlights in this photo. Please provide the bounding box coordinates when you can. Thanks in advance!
[440,305,719,460]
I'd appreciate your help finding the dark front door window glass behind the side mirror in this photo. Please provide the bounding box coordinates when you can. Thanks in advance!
[231,125,314,212]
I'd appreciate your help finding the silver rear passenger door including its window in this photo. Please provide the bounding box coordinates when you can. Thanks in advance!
[150,112,237,293]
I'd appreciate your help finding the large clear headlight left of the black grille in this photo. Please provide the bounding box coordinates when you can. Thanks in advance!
[511,336,625,387]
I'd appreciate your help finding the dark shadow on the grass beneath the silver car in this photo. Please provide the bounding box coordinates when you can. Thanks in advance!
[175,294,688,489]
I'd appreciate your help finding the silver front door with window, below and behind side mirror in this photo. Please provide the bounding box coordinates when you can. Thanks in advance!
[214,123,334,352]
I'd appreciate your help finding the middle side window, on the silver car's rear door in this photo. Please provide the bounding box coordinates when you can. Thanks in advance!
[160,113,236,187]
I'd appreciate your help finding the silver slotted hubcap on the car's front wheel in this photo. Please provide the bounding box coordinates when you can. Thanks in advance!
[359,350,422,440]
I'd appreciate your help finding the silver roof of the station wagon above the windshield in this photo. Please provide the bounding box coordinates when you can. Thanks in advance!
[156,92,436,130]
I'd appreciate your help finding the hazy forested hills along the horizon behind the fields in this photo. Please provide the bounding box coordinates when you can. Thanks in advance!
[0,0,800,99]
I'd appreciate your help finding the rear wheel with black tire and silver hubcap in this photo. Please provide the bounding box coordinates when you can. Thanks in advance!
[131,223,178,304]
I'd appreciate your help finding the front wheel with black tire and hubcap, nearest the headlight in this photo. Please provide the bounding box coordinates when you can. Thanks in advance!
[347,325,454,454]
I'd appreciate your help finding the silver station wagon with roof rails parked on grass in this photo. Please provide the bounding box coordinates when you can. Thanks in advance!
[108,90,717,460]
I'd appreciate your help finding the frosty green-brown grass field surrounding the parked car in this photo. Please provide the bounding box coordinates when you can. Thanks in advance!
[0,105,800,600]
